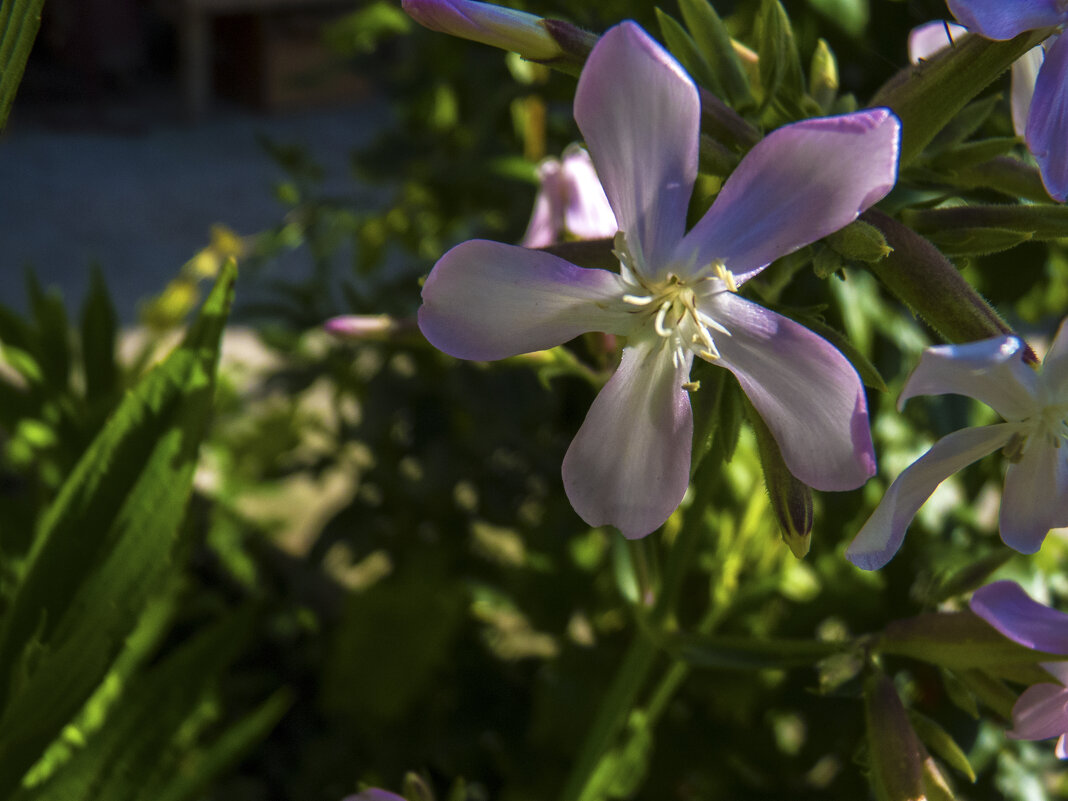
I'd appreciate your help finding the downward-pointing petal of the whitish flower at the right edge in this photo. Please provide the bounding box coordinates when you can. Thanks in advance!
[999,431,1068,553]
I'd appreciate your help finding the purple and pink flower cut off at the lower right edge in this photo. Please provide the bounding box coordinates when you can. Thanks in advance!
[971,581,1068,759]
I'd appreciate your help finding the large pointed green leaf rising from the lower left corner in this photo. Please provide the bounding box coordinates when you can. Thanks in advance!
[0,263,236,797]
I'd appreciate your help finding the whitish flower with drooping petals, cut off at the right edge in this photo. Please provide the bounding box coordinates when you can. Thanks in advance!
[846,324,1068,570]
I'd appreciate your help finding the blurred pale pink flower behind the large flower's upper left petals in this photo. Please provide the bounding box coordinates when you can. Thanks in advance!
[520,144,619,248]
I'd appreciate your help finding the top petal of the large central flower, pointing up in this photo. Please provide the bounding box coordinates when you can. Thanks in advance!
[575,22,701,280]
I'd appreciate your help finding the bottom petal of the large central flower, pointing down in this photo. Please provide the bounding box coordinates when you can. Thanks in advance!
[563,336,693,538]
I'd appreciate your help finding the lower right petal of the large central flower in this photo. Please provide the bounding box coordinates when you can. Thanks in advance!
[702,293,875,490]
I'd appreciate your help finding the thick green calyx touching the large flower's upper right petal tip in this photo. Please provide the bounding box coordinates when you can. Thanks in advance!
[869,28,1055,167]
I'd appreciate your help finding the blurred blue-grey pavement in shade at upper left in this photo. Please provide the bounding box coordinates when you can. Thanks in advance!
[0,77,388,321]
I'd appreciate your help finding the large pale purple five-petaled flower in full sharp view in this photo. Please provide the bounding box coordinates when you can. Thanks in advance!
[419,22,900,537]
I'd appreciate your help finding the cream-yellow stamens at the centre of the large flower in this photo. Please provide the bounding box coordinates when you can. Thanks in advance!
[614,232,738,367]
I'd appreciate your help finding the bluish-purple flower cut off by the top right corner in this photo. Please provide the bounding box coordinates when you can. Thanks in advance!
[947,0,1068,203]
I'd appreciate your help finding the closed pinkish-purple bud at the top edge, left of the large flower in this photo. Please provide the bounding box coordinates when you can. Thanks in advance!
[402,0,564,61]
